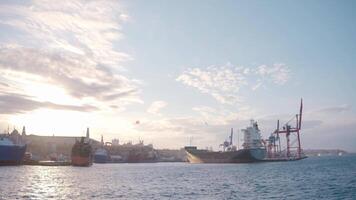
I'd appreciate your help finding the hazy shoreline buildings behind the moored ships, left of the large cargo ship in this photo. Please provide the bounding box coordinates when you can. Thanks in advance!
[0,127,186,162]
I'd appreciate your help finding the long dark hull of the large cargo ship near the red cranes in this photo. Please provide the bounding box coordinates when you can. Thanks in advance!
[186,149,266,163]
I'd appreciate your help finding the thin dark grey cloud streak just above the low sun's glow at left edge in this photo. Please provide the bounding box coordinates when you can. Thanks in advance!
[0,93,97,114]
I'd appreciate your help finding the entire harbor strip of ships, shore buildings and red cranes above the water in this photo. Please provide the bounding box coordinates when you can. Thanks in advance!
[0,100,330,167]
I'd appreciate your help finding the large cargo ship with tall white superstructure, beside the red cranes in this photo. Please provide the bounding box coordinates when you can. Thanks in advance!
[185,120,266,163]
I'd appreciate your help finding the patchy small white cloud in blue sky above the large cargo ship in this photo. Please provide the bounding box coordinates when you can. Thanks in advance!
[176,64,290,104]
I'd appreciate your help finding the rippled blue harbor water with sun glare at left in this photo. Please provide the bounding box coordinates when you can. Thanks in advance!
[0,156,356,199]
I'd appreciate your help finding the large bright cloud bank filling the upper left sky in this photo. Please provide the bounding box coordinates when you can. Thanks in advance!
[0,0,142,112]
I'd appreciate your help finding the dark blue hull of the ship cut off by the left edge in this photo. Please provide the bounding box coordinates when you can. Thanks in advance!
[0,145,26,165]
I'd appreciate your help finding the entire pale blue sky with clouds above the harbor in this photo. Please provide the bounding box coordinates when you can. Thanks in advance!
[0,0,356,152]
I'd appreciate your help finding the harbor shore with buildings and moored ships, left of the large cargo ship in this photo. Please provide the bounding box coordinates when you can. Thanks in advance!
[0,127,185,166]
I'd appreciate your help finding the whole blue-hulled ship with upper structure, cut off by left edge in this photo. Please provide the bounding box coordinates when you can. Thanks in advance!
[0,129,26,165]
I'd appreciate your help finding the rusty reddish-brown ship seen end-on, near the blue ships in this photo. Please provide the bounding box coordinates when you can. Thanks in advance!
[71,137,93,167]
